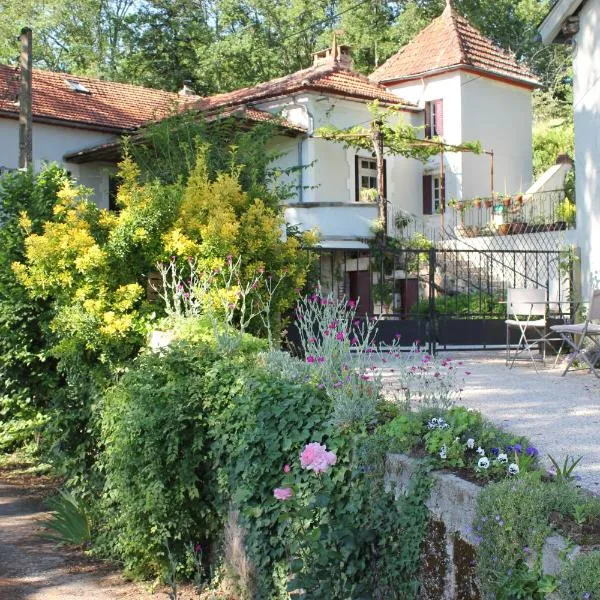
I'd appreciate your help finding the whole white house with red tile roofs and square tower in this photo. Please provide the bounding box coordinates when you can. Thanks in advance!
[0,2,538,262]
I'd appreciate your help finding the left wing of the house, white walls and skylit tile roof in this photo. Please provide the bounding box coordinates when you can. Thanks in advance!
[0,65,185,208]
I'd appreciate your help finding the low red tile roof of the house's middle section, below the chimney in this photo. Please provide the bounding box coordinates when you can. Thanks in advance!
[191,63,415,111]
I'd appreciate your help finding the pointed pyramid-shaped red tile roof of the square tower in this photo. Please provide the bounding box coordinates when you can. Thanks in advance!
[370,3,540,87]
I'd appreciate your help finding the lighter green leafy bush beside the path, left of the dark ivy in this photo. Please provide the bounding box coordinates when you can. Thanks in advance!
[99,345,230,575]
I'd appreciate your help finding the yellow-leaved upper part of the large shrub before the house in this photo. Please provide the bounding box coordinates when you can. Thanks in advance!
[13,147,310,363]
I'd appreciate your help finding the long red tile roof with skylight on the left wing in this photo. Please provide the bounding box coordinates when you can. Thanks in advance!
[0,65,184,132]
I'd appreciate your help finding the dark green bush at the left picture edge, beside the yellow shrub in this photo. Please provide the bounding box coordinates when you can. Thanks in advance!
[0,166,66,451]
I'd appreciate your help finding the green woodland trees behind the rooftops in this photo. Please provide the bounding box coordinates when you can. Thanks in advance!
[0,0,571,115]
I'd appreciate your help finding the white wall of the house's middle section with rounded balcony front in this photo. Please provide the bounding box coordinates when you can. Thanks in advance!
[259,93,423,239]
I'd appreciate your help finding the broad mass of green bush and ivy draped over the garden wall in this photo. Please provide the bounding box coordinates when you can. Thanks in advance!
[97,325,436,600]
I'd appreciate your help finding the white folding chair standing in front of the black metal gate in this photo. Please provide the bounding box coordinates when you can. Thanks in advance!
[505,288,548,372]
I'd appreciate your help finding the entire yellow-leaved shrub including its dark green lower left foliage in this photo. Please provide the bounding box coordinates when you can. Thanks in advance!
[8,145,311,488]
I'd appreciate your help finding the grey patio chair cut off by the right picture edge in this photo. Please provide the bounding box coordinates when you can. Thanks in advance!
[550,290,600,377]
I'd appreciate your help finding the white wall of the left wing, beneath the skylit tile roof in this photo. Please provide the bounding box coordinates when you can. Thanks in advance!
[0,118,115,207]
